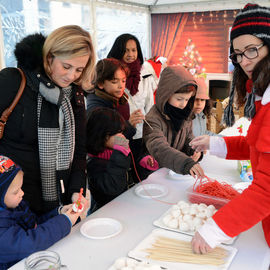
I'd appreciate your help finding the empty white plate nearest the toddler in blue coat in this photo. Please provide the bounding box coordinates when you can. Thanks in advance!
[80,218,123,239]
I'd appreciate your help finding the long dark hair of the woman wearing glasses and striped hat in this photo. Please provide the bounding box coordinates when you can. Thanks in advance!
[233,45,270,106]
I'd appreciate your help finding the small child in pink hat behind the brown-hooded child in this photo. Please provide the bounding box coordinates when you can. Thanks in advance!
[192,78,220,137]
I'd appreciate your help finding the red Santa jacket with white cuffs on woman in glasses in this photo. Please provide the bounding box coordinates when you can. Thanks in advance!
[198,85,270,247]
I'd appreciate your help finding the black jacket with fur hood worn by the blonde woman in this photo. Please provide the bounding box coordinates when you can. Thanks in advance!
[0,34,86,214]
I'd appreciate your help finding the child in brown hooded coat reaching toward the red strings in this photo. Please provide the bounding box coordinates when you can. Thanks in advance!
[143,66,204,177]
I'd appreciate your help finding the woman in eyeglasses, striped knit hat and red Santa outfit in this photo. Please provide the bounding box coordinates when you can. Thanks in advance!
[191,4,270,253]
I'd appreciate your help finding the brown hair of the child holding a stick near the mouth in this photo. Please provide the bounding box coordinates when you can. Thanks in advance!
[94,58,129,87]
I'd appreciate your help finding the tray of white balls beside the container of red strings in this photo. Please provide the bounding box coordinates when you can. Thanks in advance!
[153,201,236,245]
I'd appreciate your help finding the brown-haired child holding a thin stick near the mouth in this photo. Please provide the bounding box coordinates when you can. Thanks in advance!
[87,58,141,139]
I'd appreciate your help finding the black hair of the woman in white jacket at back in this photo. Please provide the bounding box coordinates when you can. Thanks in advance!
[107,34,143,65]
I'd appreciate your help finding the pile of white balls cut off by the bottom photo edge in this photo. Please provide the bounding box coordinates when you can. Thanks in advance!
[108,257,165,270]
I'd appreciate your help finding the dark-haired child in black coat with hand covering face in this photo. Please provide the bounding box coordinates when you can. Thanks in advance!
[86,108,134,212]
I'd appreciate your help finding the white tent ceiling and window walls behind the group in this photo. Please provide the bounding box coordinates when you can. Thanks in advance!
[0,0,270,69]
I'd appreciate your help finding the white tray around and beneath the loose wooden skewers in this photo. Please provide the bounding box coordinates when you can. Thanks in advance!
[128,229,237,270]
